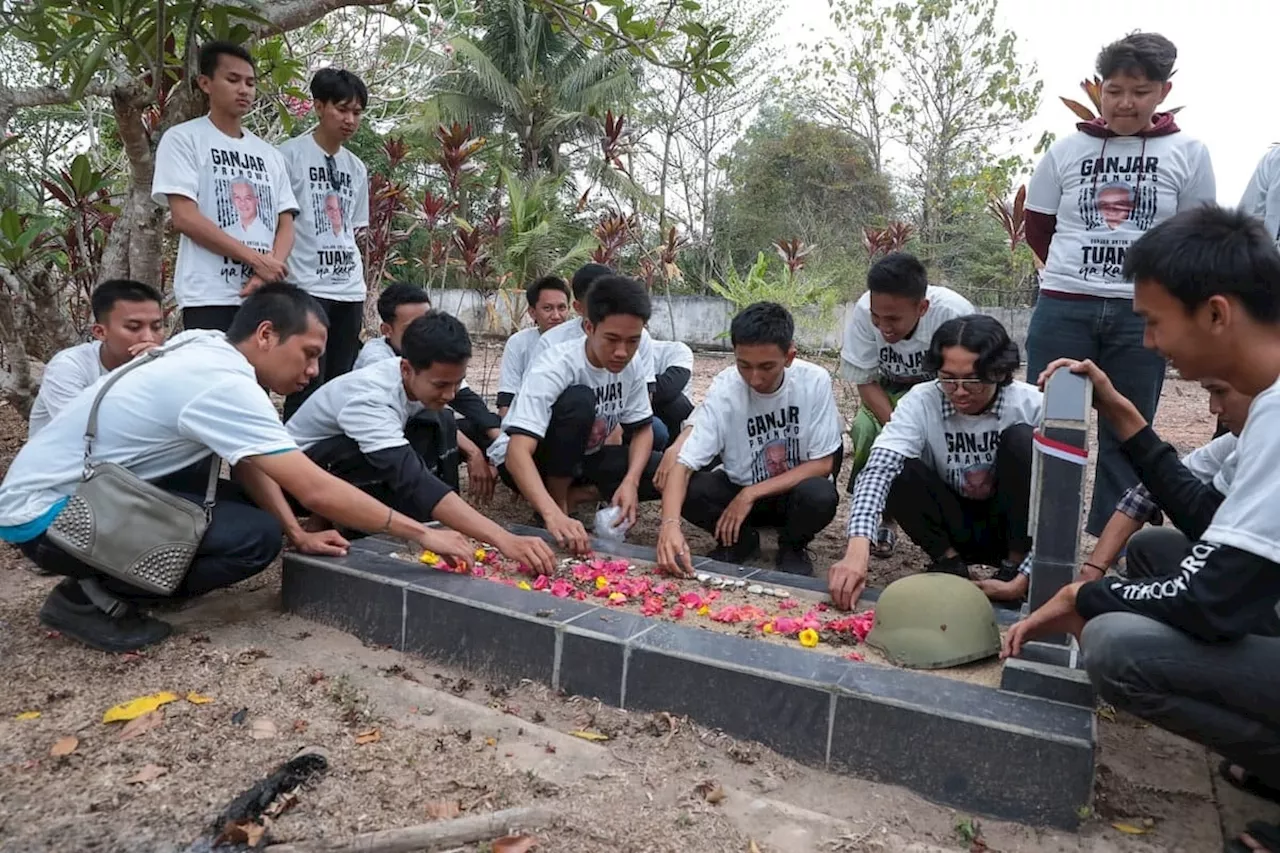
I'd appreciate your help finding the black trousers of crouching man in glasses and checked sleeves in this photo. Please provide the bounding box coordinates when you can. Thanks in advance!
[884,424,1034,566]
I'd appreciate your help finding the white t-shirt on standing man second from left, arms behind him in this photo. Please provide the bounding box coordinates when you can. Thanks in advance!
[280,133,369,302]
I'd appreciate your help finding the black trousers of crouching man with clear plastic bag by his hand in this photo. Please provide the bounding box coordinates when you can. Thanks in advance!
[498,386,662,501]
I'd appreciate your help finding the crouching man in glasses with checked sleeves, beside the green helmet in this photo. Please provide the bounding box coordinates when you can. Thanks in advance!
[827,314,1042,608]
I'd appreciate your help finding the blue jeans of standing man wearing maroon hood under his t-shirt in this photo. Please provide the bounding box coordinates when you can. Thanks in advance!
[1027,293,1165,535]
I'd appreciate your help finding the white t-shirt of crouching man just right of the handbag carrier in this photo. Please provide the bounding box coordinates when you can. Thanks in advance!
[285,359,424,455]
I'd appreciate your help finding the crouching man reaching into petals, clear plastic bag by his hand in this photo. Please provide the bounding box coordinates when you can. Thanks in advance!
[489,275,662,553]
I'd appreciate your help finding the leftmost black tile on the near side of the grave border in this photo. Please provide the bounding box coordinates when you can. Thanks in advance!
[280,555,404,648]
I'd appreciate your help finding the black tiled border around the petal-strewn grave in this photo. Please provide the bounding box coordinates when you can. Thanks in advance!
[282,525,1097,829]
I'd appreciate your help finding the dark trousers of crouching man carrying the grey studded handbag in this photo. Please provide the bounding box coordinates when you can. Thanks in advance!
[19,462,284,602]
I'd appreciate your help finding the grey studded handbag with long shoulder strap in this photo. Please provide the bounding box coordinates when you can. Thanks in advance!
[45,339,221,596]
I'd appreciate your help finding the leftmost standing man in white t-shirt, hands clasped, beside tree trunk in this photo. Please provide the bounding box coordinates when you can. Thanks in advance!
[151,41,298,330]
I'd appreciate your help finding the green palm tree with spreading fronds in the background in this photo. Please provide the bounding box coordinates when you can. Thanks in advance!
[433,0,636,175]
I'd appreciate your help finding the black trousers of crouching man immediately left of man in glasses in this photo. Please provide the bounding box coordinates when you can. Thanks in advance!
[681,467,840,551]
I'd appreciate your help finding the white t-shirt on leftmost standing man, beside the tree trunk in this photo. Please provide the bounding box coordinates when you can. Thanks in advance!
[151,115,298,307]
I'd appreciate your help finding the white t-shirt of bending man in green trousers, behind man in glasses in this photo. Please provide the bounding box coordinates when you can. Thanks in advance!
[840,284,974,384]
